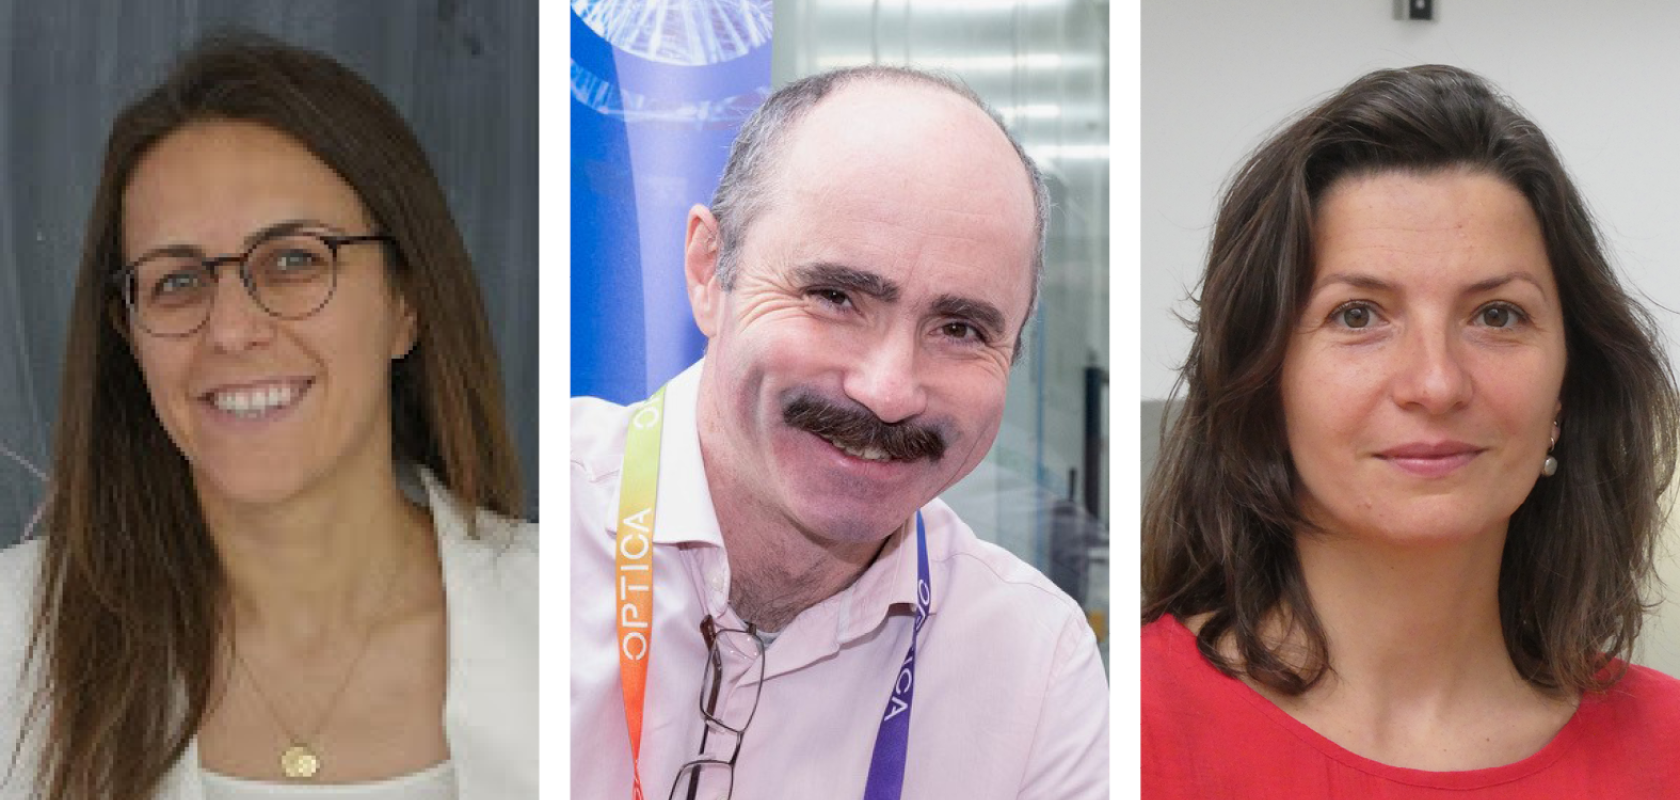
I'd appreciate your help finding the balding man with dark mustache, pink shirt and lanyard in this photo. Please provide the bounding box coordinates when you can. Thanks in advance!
[571,67,1109,800]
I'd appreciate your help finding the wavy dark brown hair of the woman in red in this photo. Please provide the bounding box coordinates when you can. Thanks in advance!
[1142,66,1680,694]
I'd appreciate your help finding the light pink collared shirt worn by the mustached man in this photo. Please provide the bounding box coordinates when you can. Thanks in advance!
[571,361,1109,800]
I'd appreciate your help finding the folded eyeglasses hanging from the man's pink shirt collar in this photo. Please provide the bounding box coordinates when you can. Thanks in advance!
[669,613,764,800]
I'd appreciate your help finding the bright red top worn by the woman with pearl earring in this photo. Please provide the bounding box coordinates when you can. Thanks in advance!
[1142,617,1680,800]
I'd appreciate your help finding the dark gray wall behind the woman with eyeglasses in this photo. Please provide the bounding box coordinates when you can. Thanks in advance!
[0,0,538,546]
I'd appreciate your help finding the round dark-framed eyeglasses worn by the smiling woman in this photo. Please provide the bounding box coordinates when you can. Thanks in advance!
[111,230,395,336]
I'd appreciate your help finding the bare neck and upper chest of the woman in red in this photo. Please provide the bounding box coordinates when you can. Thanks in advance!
[1252,529,1576,770]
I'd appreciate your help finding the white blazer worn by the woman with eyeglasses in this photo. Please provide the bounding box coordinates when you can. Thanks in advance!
[0,471,538,800]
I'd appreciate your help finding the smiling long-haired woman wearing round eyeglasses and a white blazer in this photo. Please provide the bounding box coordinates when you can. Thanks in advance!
[0,37,536,800]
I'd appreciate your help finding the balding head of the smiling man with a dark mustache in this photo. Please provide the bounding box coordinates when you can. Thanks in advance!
[684,69,1043,545]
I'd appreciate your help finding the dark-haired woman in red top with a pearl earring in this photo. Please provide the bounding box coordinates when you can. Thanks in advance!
[1142,66,1680,800]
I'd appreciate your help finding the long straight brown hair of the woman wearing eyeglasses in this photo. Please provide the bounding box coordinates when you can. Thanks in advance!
[19,32,521,800]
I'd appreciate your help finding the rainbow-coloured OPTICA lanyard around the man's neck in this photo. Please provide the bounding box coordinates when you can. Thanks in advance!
[613,387,932,800]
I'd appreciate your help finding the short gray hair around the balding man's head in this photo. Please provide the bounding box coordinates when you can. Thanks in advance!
[711,64,1050,346]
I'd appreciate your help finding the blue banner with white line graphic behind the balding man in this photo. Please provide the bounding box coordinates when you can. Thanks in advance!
[571,0,771,403]
